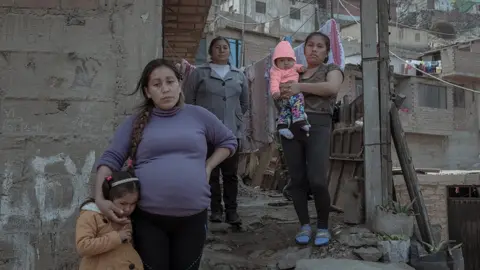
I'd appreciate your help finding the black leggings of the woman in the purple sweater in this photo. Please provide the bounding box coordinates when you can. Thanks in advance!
[132,209,207,270]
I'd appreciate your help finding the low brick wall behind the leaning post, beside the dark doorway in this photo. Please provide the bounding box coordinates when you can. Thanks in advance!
[394,174,480,240]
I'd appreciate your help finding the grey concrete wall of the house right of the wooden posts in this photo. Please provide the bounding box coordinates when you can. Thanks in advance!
[392,77,480,169]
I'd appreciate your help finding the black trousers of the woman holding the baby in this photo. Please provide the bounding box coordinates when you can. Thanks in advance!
[282,114,332,229]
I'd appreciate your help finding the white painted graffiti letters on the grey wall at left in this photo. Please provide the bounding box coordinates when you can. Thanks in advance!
[0,151,95,270]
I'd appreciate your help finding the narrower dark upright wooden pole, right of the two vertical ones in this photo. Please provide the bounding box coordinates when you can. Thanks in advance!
[378,0,393,204]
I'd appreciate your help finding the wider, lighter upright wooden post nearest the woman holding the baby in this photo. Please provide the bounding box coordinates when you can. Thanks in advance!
[361,0,383,226]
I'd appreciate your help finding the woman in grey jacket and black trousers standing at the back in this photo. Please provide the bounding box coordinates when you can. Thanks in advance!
[183,37,249,224]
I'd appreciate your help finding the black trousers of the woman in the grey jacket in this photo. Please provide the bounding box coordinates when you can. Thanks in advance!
[207,140,239,213]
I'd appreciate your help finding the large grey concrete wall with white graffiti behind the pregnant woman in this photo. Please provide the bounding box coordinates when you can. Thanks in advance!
[0,0,162,270]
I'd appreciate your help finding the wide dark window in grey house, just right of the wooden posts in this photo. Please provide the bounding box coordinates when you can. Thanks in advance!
[418,83,447,109]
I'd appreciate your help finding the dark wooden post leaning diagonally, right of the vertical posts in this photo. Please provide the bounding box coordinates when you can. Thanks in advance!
[390,99,433,244]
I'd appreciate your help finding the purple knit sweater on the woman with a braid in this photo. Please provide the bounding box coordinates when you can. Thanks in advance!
[97,105,237,217]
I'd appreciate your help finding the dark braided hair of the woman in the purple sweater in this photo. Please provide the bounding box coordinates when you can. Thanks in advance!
[129,59,185,167]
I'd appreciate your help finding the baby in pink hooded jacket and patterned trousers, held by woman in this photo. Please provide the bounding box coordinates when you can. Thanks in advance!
[270,41,310,139]
